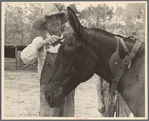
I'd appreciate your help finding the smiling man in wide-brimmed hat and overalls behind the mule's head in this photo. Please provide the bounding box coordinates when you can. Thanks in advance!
[21,3,74,117]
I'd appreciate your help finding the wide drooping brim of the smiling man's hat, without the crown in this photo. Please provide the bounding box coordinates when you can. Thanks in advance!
[32,12,68,31]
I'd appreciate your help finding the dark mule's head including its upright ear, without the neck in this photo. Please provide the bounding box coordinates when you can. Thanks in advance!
[45,7,98,107]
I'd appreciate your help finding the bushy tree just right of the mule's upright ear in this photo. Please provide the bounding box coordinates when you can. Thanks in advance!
[81,4,113,29]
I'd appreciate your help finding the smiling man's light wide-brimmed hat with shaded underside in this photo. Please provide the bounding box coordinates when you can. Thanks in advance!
[32,3,67,31]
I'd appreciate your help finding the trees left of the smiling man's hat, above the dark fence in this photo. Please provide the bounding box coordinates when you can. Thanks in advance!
[5,3,42,45]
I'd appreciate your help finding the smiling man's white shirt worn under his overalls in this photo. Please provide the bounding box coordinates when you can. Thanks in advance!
[21,33,63,74]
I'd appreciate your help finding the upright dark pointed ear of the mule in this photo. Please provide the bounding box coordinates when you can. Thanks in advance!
[67,7,83,35]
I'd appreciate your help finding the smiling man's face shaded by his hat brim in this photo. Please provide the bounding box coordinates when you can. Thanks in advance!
[45,15,61,33]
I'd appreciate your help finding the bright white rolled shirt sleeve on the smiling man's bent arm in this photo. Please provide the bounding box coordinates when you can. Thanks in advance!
[21,37,43,64]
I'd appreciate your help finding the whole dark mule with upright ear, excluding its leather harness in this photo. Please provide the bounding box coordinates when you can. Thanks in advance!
[45,7,145,117]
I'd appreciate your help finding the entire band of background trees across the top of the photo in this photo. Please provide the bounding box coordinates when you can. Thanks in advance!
[4,2,146,45]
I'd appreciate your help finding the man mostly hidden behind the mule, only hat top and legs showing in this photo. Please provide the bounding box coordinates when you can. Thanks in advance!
[97,28,133,117]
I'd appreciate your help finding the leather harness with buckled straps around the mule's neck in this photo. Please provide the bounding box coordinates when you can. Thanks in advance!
[108,36,141,117]
